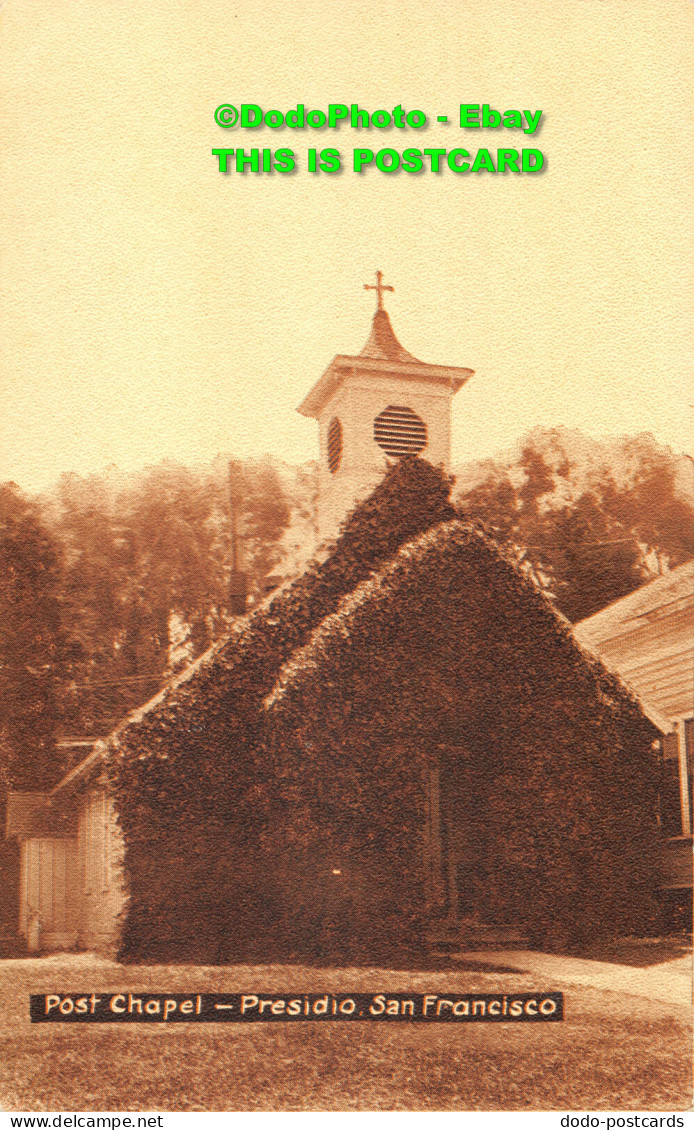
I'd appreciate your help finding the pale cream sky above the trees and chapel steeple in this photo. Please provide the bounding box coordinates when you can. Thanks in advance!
[0,0,694,492]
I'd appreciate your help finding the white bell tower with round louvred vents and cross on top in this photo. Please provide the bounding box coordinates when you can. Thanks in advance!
[297,271,472,541]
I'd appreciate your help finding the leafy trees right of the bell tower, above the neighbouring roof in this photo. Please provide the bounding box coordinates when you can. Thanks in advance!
[458,431,694,622]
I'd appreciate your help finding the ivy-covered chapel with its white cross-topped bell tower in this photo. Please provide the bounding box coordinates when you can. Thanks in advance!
[1,272,669,961]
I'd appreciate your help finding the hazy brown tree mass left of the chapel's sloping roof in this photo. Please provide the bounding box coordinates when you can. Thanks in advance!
[0,460,293,935]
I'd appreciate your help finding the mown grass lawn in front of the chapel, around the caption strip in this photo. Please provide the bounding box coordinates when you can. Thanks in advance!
[0,955,692,1112]
